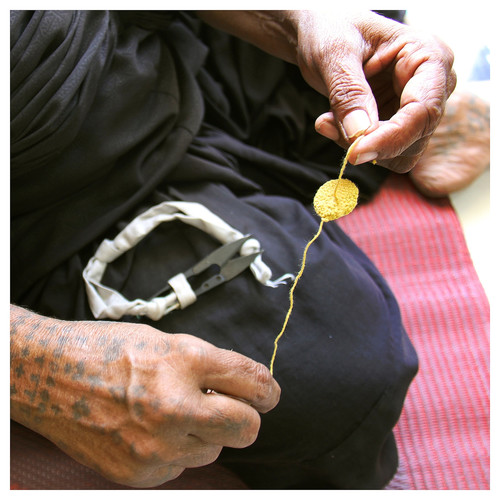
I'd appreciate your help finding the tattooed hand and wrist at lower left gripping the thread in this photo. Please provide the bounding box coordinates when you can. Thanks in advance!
[11,306,280,487]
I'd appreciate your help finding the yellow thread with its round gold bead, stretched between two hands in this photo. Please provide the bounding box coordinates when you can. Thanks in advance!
[269,136,362,375]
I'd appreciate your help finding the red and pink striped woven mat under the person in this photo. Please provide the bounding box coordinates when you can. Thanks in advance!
[11,175,489,490]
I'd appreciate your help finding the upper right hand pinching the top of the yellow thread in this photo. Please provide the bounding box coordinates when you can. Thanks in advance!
[292,11,456,172]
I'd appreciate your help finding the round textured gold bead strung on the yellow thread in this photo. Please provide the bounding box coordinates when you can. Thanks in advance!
[314,179,359,221]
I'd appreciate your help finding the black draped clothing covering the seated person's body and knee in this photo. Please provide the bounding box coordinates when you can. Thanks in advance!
[11,11,417,488]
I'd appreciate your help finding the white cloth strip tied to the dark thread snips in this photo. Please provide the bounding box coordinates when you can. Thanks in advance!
[83,201,293,320]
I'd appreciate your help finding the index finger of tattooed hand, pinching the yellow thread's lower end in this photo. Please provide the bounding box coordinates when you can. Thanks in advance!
[200,347,281,413]
